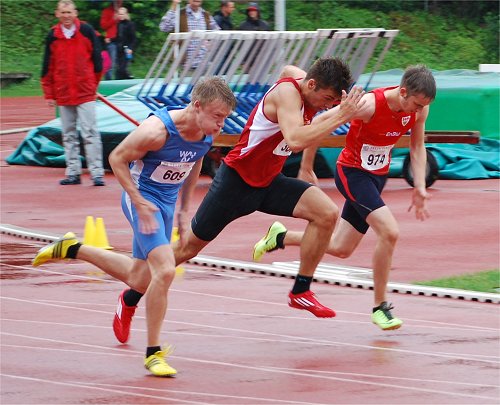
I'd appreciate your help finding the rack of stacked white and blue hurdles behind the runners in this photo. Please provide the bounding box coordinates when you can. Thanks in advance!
[137,28,399,134]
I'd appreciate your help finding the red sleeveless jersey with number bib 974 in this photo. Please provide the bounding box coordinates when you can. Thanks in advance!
[337,86,416,175]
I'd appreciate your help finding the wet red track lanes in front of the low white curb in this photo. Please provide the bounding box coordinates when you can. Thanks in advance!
[0,239,500,404]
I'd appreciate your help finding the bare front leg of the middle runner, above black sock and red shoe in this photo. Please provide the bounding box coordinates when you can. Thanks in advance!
[292,187,339,277]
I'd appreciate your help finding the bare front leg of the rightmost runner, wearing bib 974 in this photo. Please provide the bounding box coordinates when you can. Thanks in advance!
[366,206,399,306]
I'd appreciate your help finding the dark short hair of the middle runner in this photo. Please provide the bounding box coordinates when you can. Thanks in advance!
[305,57,353,96]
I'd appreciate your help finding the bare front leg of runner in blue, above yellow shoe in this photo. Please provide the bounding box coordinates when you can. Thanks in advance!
[146,245,175,347]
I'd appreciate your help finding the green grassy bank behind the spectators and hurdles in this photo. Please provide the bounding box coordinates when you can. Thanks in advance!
[0,0,499,96]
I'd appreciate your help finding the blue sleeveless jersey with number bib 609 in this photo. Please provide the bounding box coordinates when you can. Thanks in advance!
[130,108,213,204]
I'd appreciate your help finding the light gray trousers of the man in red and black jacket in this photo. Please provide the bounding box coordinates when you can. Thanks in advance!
[59,101,104,178]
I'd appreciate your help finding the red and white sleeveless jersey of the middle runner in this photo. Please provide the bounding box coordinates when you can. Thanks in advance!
[224,77,316,187]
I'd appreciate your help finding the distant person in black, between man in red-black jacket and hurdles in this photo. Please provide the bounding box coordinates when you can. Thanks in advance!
[116,7,137,80]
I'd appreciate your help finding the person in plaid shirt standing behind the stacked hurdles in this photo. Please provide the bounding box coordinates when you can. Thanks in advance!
[160,0,220,69]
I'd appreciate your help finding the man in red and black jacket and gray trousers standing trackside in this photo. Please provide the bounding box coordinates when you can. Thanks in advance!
[41,0,104,186]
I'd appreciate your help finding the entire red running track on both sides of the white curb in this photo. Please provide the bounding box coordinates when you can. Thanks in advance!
[0,95,500,404]
